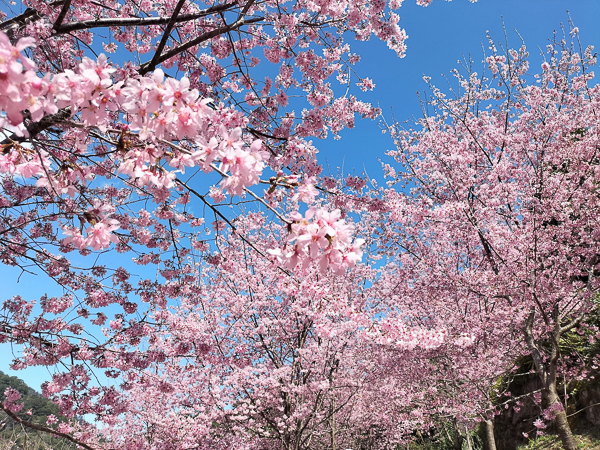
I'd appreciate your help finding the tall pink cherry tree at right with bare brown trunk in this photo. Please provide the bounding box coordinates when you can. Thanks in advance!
[381,28,600,449]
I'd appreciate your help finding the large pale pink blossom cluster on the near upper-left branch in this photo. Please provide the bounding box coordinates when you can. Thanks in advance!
[0,33,265,196]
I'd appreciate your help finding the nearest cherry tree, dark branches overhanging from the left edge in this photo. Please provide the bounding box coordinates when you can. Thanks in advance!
[0,0,478,448]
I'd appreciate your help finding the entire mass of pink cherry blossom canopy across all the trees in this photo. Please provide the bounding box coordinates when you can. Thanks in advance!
[0,0,600,450]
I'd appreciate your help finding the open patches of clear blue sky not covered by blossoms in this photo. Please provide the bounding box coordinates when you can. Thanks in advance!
[0,0,600,388]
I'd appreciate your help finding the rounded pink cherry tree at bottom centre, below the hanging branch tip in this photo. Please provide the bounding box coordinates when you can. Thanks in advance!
[88,214,432,450]
